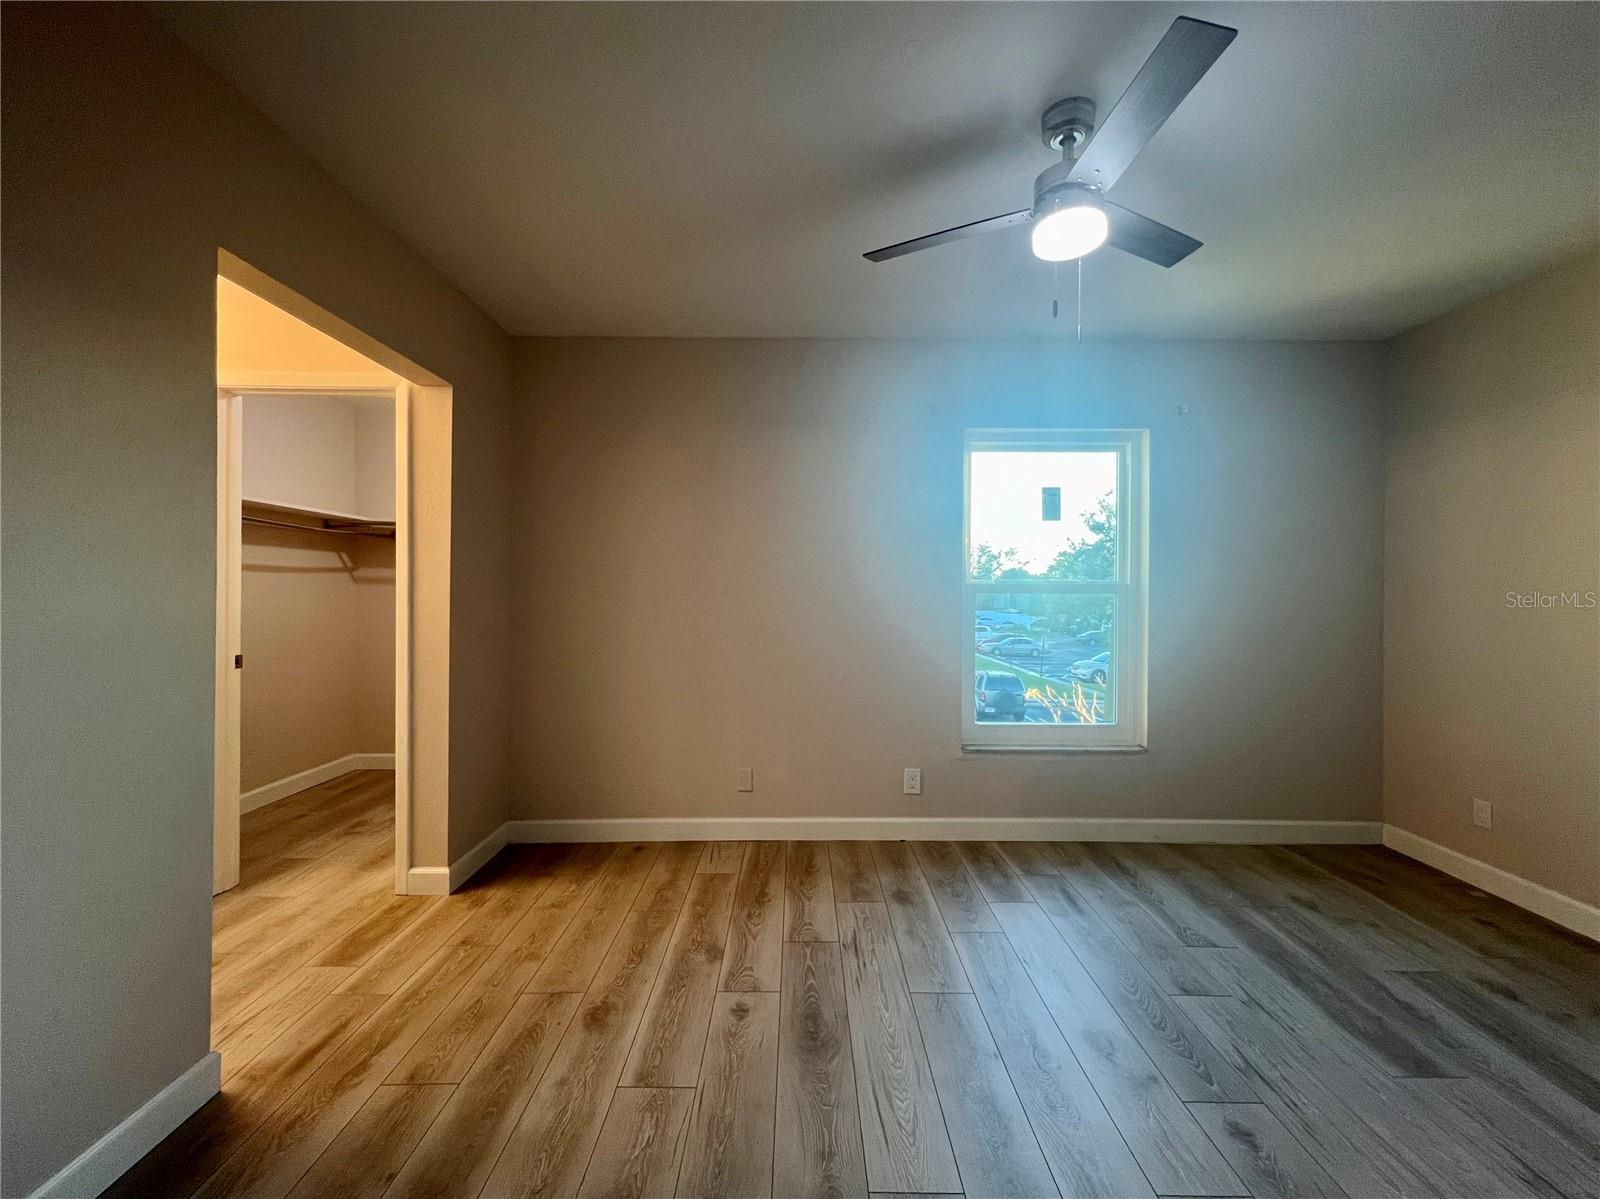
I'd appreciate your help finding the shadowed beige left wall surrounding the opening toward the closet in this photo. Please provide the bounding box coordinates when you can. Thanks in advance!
[0,5,510,1196]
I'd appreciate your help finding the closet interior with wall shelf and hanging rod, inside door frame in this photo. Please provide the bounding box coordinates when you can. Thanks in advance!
[237,392,395,813]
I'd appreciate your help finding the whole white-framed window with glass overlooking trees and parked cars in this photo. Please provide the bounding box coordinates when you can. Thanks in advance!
[962,429,1147,749]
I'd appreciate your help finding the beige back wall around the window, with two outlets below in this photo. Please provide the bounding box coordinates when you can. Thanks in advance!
[514,339,1382,820]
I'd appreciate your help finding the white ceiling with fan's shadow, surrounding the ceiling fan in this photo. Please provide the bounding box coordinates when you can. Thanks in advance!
[158,3,1600,338]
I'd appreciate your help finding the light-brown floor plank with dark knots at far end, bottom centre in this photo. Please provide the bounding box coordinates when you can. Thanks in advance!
[838,903,962,1191]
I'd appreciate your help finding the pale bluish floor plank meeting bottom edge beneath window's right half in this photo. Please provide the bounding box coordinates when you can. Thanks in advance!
[955,933,1155,1199]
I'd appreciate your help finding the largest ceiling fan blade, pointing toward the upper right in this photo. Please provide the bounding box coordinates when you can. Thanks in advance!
[1067,16,1238,187]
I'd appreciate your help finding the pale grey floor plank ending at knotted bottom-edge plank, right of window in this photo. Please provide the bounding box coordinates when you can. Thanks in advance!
[1027,876,1259,1103]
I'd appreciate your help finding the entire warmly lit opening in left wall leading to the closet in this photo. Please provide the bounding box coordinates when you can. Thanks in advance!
[213,259,456,896]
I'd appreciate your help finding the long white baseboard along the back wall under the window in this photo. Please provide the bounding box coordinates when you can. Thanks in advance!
[506,816,1384,845]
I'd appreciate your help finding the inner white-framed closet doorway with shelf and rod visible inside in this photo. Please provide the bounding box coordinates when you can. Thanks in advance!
[213,376,410,892]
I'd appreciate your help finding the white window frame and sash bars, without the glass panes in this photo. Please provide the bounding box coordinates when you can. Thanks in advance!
[962,429,1150,752]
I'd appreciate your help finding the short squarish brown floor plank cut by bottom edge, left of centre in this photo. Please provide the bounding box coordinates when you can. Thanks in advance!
[578,1082,697,1199]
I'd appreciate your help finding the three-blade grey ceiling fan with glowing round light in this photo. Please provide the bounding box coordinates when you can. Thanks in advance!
[864,16,1238,266]
